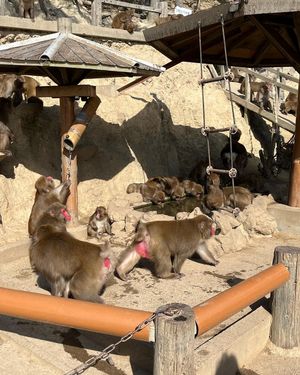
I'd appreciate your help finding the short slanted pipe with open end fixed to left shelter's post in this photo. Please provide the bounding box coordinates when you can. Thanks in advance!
[63,96,101,151]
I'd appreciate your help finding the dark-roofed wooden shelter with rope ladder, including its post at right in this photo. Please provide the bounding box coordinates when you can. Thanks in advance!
[144,0,300,207]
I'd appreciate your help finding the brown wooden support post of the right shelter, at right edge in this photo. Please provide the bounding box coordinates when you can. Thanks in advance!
[289,82,300,207]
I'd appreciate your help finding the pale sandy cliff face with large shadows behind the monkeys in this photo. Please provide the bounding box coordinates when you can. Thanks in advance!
[0,1,259,244]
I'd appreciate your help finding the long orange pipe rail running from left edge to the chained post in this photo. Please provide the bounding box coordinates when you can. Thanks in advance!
[0,288,152,341]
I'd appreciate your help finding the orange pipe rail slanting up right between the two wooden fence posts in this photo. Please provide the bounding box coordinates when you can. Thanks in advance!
[193,264,290,335]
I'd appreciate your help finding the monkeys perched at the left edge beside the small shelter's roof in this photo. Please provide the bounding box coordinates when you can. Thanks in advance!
[0,74,42,160]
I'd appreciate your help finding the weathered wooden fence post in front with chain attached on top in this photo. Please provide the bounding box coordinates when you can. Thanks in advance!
[153,303,196,375]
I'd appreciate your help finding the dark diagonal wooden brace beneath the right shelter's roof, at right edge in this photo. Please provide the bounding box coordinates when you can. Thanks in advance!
[249,16,300,72]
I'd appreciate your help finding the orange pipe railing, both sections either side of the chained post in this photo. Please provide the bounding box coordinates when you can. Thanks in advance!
[0,264,289,341]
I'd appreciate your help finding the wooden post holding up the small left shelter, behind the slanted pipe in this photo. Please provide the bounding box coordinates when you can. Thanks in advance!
[60,97,78,225]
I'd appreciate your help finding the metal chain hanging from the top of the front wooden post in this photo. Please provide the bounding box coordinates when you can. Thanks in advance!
[65,307,181,375]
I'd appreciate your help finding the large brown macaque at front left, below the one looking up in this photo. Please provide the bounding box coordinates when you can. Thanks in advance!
[29,202,112,303]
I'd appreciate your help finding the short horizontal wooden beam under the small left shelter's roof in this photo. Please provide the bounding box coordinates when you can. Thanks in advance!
[36,85,96,98]
